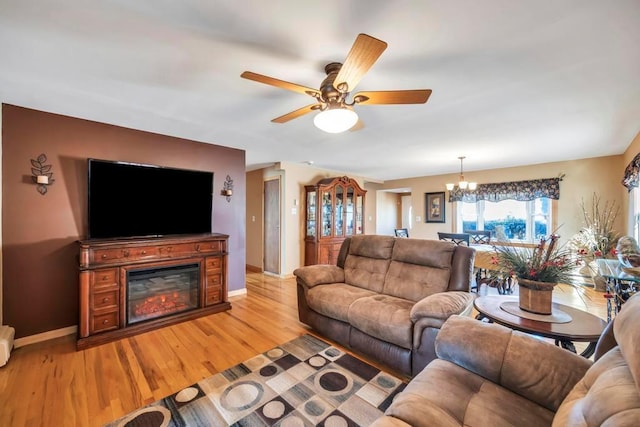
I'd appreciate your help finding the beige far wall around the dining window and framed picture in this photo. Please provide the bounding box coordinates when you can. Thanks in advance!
[384,156,624,244]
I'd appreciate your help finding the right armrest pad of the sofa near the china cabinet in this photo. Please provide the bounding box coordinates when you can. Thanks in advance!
[411,291,476,323]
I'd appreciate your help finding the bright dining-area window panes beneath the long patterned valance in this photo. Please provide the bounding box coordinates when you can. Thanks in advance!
[457,197,553,242]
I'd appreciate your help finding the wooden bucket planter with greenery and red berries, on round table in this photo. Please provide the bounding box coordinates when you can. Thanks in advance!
[494,233,575,315]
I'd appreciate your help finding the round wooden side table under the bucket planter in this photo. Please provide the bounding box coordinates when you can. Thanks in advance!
[473,296,607,358]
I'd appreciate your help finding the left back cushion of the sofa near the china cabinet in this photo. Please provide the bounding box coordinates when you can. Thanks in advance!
[344,235,396,292]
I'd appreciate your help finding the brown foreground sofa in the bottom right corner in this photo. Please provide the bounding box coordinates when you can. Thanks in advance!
[373,294,640,427]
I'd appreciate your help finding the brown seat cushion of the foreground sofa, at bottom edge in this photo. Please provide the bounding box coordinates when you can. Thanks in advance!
[385,360,553,427]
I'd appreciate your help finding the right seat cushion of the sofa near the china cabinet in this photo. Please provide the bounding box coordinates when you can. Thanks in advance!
[349,294,414,349]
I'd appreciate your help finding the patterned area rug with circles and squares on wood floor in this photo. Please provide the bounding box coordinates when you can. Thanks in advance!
[106,335,406,427]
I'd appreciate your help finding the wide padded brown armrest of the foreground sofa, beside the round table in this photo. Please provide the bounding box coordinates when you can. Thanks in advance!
[436,316,592,412]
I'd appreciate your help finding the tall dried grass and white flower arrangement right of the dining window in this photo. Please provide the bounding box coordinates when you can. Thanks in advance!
[569,193,620,262]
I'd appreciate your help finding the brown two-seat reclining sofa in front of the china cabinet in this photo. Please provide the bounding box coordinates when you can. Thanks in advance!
[293,235,475,376]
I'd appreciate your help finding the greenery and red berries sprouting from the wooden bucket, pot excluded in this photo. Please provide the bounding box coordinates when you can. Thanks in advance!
[492,233,576,285]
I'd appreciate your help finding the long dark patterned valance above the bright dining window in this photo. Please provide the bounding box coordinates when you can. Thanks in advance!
[449,176,562,203]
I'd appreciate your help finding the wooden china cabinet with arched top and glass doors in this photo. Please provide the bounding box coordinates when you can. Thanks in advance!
[304,176,366,265]
